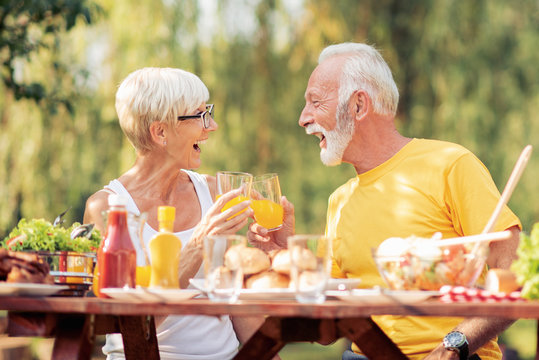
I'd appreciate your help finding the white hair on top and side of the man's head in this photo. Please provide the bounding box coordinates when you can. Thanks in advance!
[318,43,399,116]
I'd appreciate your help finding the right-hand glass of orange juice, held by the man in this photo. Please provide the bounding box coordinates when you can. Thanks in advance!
[251,173,284,231]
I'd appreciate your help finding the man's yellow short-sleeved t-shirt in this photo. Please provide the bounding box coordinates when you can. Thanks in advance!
[326,139,521,360]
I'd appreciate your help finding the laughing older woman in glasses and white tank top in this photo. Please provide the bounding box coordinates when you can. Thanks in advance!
[84,68,258,360]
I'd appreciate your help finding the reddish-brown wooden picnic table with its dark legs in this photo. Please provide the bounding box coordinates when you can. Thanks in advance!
[0,297,539,360]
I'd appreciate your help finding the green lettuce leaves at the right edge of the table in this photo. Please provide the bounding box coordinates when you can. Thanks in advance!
[511,223,539,299]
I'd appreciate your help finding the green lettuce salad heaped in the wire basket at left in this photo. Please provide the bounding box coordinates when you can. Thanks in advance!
[2,218,101,252]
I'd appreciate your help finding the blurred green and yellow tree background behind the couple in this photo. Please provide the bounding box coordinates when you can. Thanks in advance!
[0,0,539,358]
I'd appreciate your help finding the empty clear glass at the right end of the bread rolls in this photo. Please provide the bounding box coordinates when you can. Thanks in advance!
[288,235,331,304]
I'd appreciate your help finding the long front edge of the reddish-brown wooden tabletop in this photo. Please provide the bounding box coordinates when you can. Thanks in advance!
[0,297,539,319]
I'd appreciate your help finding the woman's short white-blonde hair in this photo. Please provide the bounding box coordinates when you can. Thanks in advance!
[116,67,210,153]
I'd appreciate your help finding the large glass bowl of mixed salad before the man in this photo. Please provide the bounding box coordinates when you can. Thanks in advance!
[373,236,488,290]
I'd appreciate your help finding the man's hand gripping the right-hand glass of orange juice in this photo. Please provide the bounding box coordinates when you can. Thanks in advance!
[247,196,296,251]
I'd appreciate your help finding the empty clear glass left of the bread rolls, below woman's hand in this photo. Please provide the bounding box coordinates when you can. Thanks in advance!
[203,235,247,303]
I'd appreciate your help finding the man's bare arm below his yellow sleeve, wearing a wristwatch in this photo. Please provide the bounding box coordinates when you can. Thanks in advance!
[425,226,520,360]
